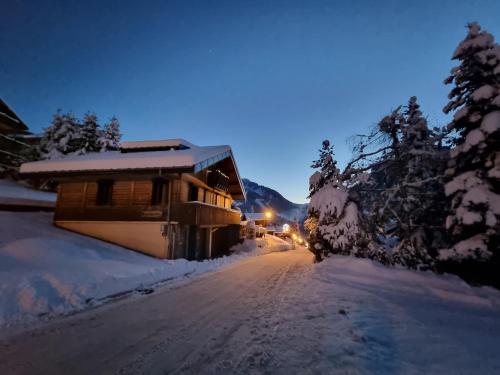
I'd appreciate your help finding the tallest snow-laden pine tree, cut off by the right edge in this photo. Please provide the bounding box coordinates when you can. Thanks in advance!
[440,23,500,285]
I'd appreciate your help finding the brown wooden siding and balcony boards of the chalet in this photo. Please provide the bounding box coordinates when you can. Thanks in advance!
[55,173,240,226]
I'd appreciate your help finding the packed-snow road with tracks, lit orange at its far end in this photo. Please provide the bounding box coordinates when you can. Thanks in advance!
[0,249,320,374]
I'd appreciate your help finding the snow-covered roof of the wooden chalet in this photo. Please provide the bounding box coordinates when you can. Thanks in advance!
[20,139,245,198]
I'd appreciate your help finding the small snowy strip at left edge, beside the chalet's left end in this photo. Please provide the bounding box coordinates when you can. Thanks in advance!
[0,179,56,207]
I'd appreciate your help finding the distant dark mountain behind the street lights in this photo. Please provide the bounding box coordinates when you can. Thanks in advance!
[235,178,307,224]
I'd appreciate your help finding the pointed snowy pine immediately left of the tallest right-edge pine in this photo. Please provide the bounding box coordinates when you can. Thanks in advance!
[390,96,447,268]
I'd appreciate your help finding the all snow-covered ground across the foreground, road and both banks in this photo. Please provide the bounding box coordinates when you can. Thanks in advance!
[0,212,500,375]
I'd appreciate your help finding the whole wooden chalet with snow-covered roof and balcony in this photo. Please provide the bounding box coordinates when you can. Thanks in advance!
[21,139,245,259]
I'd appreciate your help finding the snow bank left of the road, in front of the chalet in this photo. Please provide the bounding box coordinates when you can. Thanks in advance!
[0,211,290,326]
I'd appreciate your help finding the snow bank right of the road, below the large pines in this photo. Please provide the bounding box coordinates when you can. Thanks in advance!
[308,256,500,374]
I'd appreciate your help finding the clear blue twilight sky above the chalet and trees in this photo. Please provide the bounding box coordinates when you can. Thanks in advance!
[0,0,500,202]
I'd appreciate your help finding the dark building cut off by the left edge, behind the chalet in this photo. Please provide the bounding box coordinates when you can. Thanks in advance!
[0,99,31,178]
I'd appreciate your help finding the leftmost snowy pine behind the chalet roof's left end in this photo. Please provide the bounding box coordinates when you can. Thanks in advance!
[39,110,78,159]
